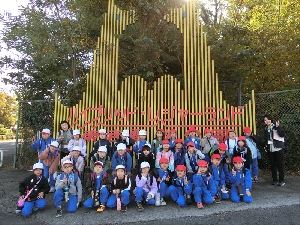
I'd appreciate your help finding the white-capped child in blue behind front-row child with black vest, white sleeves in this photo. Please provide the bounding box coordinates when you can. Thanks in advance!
[111,143,132,175]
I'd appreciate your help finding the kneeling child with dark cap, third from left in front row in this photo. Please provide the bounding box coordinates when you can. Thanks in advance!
[83,161,109,212]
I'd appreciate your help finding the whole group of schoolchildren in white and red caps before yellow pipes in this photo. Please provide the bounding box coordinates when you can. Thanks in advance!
[17,127,259,217]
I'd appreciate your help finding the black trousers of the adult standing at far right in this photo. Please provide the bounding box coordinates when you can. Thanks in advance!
[270,149,284,182]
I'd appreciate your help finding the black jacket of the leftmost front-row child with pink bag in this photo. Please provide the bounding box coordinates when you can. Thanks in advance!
[19,174,50,201]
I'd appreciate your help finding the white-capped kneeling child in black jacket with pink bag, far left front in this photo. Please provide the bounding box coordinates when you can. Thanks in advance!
[16,163,50,217]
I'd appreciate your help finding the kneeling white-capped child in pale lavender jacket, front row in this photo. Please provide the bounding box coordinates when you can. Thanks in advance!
[135,162,157,212]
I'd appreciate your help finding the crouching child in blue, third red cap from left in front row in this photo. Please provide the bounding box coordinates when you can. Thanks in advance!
[193,160,217,209]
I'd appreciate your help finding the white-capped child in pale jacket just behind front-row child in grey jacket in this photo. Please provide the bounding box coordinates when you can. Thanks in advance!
[61,146,84,179]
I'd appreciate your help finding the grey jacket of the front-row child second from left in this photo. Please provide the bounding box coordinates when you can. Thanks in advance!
[55,172,82,202]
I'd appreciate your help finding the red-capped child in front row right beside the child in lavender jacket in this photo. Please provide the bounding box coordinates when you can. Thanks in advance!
[153,158,172,205]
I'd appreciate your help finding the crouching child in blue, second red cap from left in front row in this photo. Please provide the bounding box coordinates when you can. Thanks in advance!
[169,165,193,207]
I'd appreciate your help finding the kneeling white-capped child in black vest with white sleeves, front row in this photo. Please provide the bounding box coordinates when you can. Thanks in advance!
[107,165,131,212]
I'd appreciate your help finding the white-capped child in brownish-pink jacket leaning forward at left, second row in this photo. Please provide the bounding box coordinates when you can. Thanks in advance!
[39,141,60,192]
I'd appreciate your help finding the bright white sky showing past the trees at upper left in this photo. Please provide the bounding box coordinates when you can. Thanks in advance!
[0,0,29,93]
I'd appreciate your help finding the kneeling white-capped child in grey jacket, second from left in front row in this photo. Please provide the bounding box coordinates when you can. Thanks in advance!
[54,160,82,217]
